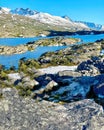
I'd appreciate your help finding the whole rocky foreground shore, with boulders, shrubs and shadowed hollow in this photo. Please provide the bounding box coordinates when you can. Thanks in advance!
[0,38,104,130]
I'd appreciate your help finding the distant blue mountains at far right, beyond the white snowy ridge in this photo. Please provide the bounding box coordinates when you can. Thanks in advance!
[78,21,102,31]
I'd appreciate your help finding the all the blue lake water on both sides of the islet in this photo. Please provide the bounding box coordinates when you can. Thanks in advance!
[0,34,104,68]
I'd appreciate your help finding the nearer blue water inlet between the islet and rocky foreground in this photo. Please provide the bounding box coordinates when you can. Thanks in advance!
[0,46,66,68]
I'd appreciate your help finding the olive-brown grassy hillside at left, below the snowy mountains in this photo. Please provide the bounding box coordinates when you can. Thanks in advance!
[0,14,70,37]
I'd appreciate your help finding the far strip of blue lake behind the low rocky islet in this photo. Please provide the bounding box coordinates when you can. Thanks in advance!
[0,34,104,46]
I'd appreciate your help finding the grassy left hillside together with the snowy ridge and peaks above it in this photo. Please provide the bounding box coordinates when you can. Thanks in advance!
[0,8,88,37]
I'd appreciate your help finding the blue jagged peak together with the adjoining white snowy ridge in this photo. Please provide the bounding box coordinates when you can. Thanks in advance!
[10,8,89,30]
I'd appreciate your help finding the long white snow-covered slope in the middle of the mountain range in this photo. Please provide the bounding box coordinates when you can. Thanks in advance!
[29,12,89,29]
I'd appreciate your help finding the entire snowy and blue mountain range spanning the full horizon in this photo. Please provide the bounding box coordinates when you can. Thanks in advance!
[0,7,104,31]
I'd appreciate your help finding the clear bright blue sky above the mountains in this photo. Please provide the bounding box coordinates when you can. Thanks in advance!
[0,0,104,25]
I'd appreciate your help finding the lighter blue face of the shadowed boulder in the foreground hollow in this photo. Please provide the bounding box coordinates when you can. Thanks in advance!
[49,81,90,102]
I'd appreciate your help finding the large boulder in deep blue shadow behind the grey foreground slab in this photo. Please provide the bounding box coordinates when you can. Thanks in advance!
[47,76,95,102]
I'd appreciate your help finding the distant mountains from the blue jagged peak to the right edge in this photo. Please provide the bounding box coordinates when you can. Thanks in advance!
[10,8,104,30]
